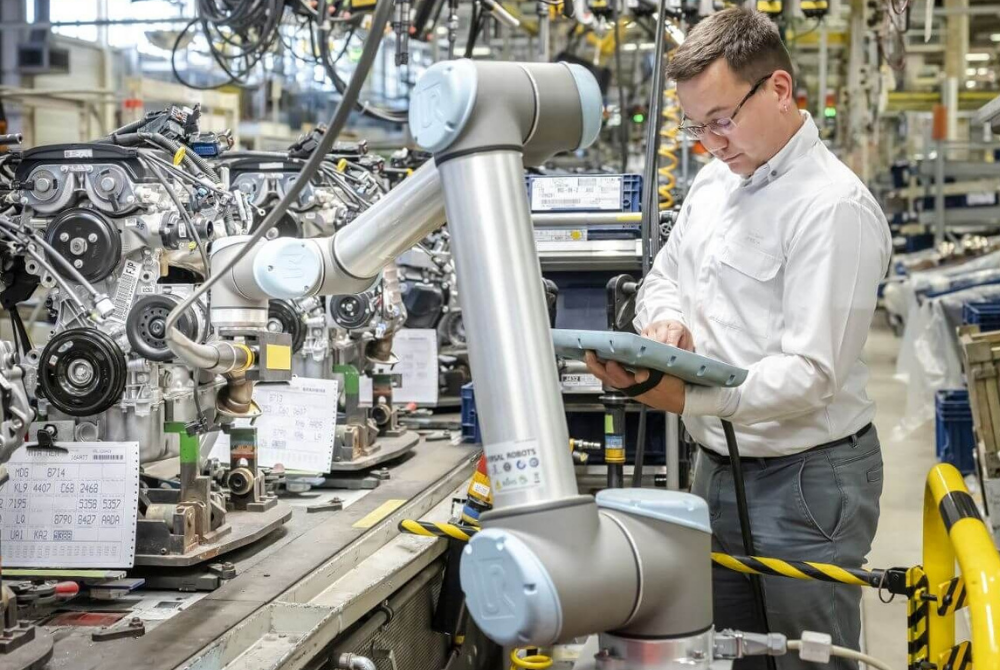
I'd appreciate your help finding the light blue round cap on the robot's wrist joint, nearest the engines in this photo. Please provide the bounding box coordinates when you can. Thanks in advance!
[253,237,323,298]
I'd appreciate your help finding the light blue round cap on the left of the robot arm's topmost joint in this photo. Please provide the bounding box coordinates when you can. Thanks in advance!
[410,59,479,153]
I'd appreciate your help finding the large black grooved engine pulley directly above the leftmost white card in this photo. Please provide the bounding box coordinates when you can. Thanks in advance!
[38,328,127,416]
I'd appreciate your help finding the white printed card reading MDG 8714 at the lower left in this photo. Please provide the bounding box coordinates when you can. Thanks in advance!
[0,442,139,568]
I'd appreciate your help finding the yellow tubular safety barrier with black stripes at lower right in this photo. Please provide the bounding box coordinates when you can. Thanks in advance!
[922,464,1000,670]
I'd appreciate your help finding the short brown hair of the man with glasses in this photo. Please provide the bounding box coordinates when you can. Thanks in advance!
[667,7,794,89]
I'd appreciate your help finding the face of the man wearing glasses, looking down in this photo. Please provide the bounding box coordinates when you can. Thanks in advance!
[677,58,780,176]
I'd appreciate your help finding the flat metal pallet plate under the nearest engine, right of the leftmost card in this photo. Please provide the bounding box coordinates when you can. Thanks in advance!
[135,502,292,568]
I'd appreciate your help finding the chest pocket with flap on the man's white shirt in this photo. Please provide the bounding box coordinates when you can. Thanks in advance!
[708,242,781,340]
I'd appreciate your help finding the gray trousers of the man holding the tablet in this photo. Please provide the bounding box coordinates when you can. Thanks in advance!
[691,426,882,670]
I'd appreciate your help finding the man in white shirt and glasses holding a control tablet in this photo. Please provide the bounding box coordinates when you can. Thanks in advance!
[588,8,891,670]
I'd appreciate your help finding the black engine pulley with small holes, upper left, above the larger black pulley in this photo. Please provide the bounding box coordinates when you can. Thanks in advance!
[45,208,122,282]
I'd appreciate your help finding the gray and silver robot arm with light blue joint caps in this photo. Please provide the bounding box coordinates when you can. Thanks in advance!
[171,60,712,667]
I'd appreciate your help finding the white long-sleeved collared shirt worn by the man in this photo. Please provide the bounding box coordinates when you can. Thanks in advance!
[635,113,892,456]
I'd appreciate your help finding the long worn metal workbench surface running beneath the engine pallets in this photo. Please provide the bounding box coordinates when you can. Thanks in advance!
[36,440,478,670]
